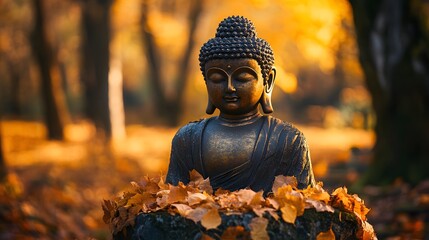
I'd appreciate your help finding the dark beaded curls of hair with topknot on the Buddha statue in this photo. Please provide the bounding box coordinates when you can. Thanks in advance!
[198,16,274,81]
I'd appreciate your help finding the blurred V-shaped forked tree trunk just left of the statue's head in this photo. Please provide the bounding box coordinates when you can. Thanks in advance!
[141,0,204,126]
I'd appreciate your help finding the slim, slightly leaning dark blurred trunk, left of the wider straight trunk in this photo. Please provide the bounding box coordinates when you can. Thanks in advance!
[32,0,65,140]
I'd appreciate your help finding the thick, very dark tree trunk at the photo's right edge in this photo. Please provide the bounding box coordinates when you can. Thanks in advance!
[350,0,429,185]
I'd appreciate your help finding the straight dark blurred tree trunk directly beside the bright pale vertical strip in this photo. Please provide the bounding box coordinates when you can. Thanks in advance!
[81,0,112,138]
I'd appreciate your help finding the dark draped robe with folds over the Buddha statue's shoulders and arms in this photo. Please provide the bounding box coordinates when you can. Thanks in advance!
[166,116,314,193]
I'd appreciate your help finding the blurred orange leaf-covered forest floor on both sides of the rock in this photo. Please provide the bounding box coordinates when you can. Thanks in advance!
[0,121,429,239]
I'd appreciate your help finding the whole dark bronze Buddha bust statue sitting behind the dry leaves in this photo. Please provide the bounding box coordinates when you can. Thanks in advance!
[166,16,314,194]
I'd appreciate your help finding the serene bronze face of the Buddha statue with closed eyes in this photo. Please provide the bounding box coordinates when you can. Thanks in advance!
[205,58,264,115]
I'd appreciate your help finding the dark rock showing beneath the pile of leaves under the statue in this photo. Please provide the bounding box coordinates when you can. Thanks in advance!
[113,209,359,240]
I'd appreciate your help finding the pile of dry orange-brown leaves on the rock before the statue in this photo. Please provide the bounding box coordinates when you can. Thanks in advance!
[103,170,375,239]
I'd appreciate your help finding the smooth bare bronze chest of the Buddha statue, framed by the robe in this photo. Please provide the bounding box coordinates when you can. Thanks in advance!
[201,118,260,177]
